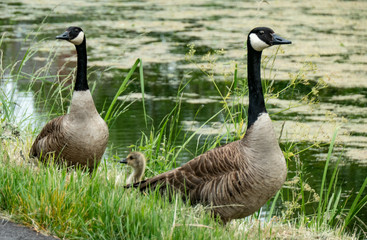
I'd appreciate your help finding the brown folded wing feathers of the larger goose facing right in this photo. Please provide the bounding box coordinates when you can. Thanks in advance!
[127,142,243,202]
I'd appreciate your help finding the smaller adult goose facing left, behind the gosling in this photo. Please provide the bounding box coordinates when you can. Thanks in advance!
[30,27,108,172]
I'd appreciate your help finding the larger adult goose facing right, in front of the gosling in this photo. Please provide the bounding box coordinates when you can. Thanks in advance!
[127,27,291,223]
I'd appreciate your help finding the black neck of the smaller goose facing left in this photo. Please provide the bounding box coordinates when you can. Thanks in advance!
[74,38,89,91]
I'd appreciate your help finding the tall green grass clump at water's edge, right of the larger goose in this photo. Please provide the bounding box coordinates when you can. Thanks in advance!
[280,128,367,237]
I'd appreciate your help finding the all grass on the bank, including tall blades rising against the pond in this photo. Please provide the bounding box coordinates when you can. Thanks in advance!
[0,36,367,239]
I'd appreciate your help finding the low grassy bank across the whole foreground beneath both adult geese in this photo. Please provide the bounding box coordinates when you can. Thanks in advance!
[0,125,362,239]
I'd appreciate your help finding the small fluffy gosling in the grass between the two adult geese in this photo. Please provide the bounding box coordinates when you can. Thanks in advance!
[120,152,146,184]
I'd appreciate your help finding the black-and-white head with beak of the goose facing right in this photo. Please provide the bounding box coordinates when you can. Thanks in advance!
[247,27,292,52]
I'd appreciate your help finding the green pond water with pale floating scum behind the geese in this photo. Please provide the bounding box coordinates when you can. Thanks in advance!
[0,0,367,228]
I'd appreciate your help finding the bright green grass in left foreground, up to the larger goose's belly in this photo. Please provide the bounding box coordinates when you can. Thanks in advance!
[0,158,239,239]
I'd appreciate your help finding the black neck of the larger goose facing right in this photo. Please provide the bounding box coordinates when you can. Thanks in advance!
[247,39,266,129]
